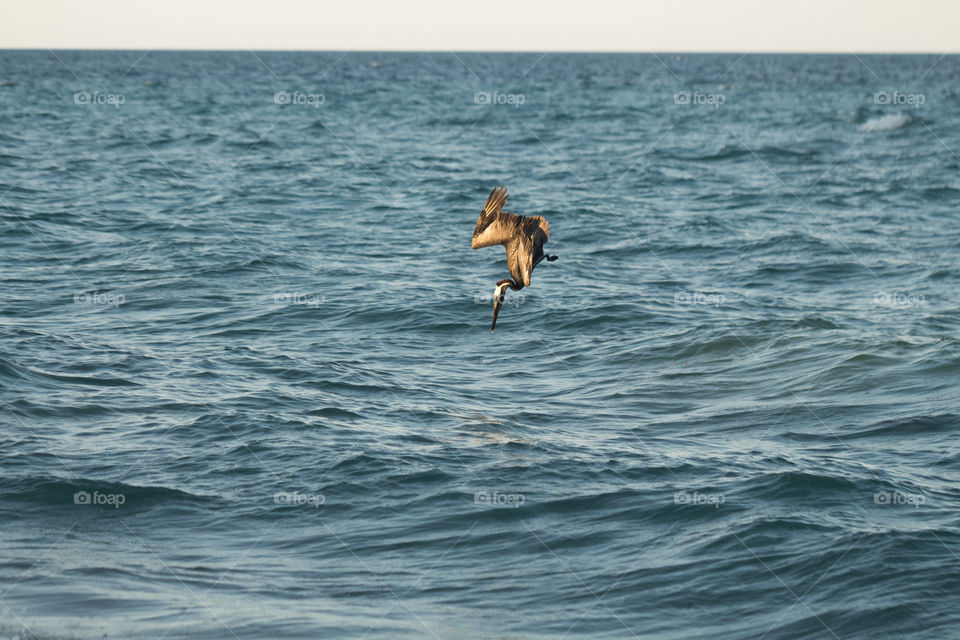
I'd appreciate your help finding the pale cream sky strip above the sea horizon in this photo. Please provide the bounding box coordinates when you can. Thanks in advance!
[0,0,960,53]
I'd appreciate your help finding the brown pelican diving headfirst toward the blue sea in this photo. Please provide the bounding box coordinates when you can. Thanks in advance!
[470,186,557,333]
